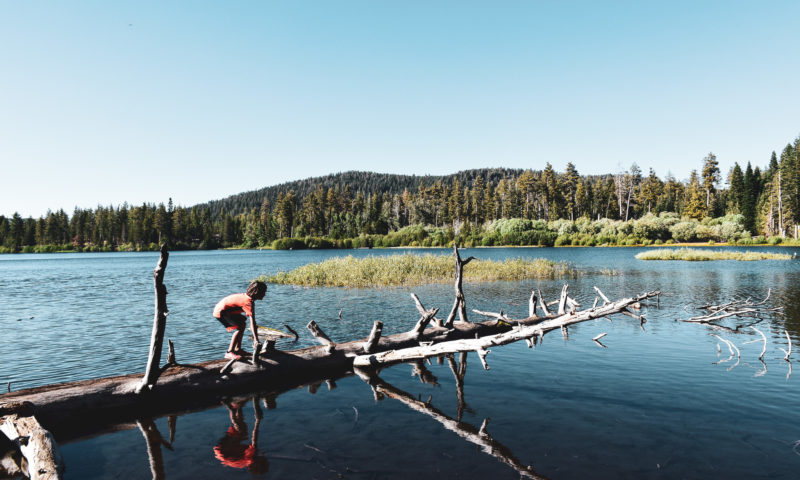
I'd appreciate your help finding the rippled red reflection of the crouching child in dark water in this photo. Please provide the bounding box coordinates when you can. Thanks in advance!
[214,403,269,473]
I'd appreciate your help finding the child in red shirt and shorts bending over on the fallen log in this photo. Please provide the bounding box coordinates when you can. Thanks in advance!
[214,281,267,360]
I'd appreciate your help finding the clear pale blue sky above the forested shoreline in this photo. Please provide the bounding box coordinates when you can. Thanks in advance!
[0,0,800,217]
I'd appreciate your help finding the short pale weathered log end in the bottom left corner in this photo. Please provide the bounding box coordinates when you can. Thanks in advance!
[0,402,64,480]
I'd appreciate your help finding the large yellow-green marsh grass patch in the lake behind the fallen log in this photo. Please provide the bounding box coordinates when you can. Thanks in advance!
[263,254,576,287]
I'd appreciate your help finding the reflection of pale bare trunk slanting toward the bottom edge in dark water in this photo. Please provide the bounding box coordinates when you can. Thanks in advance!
[356,370,544,479]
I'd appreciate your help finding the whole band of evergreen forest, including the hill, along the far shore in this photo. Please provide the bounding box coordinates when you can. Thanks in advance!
[0,137,800,252]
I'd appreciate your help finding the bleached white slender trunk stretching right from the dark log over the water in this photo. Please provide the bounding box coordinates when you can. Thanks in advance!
[353,292,658,368]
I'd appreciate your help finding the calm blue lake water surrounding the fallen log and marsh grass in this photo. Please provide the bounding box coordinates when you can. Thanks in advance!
[0,248,800,480]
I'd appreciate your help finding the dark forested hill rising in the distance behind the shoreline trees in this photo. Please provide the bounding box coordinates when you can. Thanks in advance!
[196,168,523,219]
